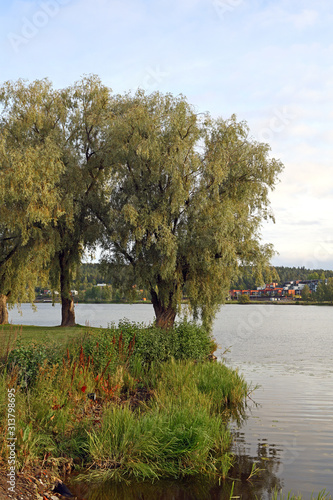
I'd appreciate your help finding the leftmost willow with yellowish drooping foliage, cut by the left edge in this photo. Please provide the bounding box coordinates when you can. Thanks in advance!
[0,111,62,324]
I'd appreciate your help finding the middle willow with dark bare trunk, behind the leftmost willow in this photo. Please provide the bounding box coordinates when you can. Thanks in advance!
[2,76,110,326]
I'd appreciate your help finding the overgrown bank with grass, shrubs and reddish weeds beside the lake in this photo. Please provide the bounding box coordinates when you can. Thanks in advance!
[0,323,249,481]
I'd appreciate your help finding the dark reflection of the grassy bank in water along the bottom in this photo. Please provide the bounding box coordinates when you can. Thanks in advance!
[70,446,283,500]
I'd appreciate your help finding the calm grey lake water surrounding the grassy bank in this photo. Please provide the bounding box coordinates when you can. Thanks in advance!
[5,304,333,500]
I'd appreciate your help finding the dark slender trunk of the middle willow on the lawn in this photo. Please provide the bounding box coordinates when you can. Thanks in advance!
[59,251,75,326]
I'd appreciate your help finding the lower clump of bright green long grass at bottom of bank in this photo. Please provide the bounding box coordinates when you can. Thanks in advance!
[87,391,231,480]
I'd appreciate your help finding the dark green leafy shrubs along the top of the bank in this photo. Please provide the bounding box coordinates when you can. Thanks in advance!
[7,320,216,388]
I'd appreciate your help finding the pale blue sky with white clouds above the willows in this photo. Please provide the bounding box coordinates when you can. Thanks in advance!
[0,0,333,269]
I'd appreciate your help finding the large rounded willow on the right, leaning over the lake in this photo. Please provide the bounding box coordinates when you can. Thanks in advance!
[100,91,282,328]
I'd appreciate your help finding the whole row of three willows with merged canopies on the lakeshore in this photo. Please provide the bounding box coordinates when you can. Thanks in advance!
[0,75,283,329]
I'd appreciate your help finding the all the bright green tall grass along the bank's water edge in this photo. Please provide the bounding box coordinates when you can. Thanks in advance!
[81,360,247,480]
